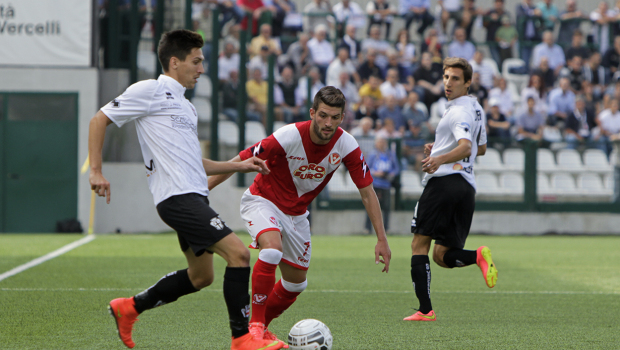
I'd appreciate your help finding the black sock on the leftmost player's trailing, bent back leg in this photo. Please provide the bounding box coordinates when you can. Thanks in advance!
[133,269,198,313]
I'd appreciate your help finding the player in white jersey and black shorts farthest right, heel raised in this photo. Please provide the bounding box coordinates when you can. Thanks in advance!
[404,57,497,321]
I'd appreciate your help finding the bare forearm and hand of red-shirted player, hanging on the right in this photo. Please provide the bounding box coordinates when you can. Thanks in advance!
[359,184,392,273]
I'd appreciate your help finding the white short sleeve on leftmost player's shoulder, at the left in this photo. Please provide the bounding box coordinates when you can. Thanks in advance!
[101,80,157,128]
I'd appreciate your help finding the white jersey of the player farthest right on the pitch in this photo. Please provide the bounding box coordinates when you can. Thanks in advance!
[422,96,487,189]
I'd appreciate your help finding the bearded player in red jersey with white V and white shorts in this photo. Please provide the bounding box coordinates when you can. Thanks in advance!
[209,86,391,340]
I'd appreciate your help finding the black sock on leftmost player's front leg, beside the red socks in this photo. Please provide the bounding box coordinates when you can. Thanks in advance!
[224,266,250,338]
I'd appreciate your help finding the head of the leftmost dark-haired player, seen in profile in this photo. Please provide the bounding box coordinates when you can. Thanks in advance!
[157,29,204,89]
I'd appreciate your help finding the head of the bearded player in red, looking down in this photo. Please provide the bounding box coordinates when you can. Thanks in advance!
[310,86,346,144]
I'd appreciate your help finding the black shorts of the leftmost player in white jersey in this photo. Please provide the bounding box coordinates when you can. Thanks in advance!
[157,193,232,256]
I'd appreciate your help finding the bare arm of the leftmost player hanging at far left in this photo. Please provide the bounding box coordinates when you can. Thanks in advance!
[88,110,112,204]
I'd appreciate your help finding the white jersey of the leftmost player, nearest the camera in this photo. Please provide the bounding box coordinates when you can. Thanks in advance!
[101,75,209,205]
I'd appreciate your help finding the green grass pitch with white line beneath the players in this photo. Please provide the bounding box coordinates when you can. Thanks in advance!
[0,234,620,350]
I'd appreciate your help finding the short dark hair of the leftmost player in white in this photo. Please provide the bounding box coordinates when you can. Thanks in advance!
[157,29,204,72]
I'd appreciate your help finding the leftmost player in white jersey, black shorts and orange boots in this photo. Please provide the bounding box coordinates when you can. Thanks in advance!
[88,30,286,350]
